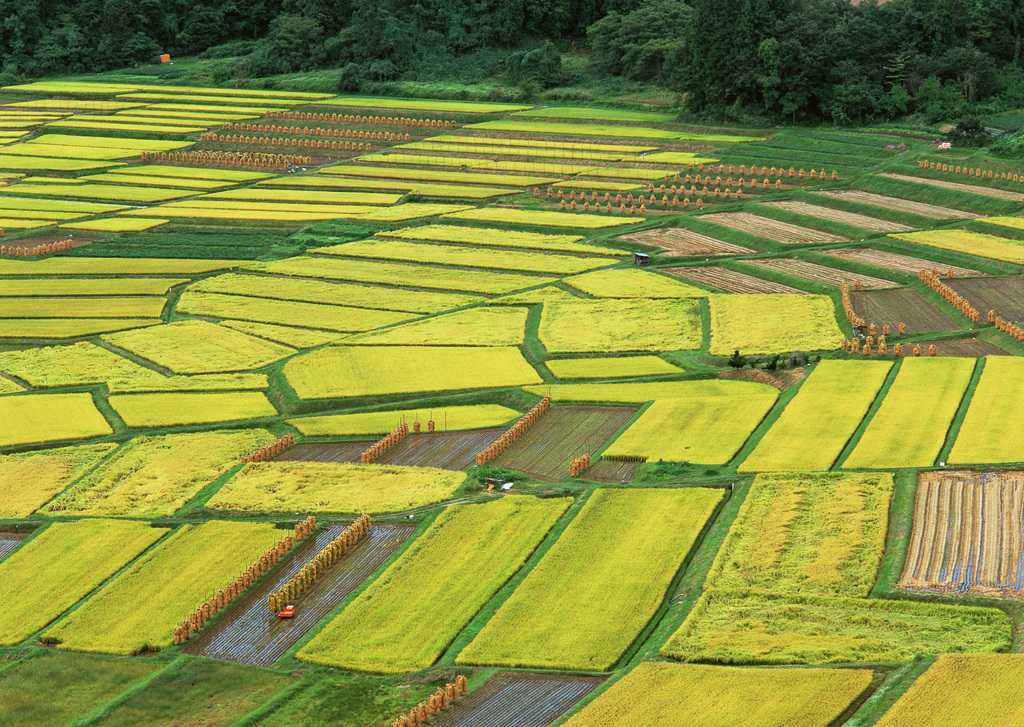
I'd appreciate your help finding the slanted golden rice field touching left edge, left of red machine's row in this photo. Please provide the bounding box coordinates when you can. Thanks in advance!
[0,519,167,645]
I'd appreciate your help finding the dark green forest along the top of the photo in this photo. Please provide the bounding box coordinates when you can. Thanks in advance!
[0,0,1024,124]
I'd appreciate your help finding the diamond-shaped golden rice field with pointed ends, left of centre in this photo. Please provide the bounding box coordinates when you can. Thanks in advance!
[103,320,294,374]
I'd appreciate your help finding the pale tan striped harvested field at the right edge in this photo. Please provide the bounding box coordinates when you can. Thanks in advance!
[899,471,1024,596]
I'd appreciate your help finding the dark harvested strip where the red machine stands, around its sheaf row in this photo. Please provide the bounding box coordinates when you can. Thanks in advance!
[185,524,415,667]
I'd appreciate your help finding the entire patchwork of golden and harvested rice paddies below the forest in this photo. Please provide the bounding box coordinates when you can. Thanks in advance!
[6,78,1024,727]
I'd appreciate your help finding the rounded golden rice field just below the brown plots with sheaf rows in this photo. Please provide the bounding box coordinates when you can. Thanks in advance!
[207,462,466,514]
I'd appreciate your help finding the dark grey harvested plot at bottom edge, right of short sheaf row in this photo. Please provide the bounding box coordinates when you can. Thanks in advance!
[430,672,604,727]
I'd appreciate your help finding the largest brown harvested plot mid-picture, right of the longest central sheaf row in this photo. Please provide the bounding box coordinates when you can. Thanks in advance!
[495,407,636,480]
